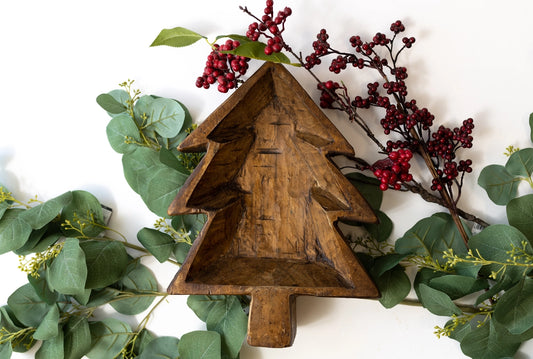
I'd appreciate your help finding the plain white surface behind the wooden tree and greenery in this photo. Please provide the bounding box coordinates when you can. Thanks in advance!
[0,0,533,359]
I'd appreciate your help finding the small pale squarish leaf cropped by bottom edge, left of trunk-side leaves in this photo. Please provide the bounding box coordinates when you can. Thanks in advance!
[178,330,221,359]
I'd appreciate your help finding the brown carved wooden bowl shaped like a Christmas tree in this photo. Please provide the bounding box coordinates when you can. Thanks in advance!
[168,63,379,347]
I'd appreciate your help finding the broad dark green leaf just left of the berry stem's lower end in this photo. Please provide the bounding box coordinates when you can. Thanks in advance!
[395,213,466,264]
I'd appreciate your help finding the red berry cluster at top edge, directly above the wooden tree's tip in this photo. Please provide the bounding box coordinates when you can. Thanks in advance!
[246,0,292,55]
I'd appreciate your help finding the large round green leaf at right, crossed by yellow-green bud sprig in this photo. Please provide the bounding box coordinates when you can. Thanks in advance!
[469,224,533,282]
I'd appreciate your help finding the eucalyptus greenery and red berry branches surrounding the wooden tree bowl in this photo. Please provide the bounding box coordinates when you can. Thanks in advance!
[0,0,533,359]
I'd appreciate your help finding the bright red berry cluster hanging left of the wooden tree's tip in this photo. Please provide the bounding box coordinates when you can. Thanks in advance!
[196,40,250,93]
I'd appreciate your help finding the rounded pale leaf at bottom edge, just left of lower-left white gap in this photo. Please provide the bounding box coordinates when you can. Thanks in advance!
[87,318,132,359]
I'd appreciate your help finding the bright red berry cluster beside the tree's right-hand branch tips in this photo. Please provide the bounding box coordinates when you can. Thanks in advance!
[371,149,413,191]
